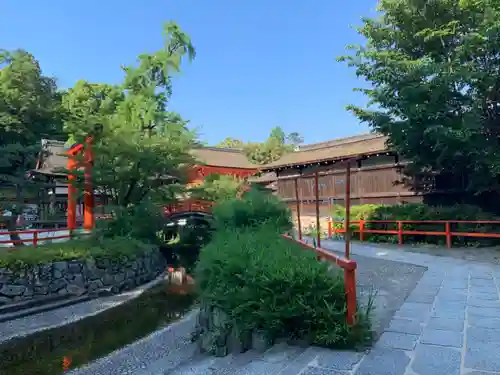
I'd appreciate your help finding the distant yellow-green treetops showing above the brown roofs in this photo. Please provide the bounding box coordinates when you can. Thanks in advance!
[216,126,304,164]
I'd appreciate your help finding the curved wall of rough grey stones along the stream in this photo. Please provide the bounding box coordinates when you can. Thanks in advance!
[0,249,166,306]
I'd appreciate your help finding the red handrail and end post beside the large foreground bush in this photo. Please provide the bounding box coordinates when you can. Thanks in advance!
[283,235,357,325]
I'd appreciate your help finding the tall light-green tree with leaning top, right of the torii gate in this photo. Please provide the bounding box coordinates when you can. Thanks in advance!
[64,23,196,208]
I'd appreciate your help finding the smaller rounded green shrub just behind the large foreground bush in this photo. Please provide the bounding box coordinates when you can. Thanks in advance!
[212,189,293,233]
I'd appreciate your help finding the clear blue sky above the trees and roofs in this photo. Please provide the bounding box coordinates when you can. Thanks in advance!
[0,0,376,144]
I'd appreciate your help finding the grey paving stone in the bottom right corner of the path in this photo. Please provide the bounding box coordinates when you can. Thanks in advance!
[464,340,500,372]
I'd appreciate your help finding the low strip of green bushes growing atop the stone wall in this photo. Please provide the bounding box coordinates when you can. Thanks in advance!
[0,237,157,269]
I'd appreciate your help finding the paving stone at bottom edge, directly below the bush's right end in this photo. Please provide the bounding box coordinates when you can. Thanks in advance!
[354,348,410,375]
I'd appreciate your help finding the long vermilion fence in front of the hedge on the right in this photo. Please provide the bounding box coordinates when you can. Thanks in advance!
[328,220,500,248]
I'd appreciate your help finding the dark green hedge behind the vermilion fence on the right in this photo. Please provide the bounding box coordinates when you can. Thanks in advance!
[331,203,500,246]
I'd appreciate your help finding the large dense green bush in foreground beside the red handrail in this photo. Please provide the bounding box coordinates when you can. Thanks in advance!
[195,226,372,347]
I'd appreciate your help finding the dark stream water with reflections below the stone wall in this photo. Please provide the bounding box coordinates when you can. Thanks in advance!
[0,285,194,375]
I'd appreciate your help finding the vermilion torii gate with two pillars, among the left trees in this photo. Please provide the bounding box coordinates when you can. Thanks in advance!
[67,137,94,231]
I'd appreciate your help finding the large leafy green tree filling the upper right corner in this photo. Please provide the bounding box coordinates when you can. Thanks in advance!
[340,0,500,191]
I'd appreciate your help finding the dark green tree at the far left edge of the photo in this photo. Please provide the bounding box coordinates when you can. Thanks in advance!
[0,50,62,244]
